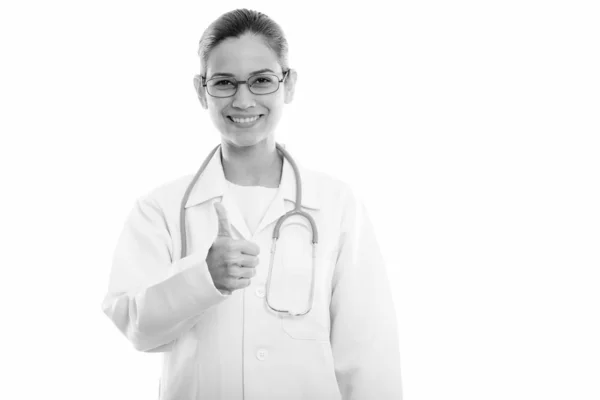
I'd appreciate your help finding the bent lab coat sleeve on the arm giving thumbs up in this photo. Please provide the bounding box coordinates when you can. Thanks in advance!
[102,197,227,352]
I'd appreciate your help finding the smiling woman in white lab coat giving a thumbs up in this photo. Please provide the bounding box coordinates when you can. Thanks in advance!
[103,10,401,400]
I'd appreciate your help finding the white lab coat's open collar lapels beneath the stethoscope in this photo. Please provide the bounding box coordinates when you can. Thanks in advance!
[185,144,320,212]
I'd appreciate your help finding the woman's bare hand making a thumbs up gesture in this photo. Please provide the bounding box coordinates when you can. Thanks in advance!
[206,203,260,294]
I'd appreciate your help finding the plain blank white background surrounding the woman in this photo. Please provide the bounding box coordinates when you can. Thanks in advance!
[0,0,600,400]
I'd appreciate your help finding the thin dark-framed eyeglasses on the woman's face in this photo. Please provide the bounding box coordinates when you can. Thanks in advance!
[202,70,290,98]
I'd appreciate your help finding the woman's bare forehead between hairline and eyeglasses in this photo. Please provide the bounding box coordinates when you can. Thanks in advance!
[206,34,281,78]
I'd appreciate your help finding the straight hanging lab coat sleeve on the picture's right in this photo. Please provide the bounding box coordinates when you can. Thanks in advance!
[330,195,402,400]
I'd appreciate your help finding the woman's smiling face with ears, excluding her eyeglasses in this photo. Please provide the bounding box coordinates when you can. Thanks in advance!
[194,34,296,147]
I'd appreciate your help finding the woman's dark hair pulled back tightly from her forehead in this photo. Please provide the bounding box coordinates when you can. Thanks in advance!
[198,8,289,75]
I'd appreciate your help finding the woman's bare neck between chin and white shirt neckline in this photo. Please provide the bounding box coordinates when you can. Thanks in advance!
[221,140,283,188]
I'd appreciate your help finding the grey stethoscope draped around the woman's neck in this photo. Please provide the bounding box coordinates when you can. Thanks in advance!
[179,143,319,317]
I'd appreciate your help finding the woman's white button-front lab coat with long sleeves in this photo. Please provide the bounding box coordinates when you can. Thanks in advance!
[102,147,401,400]
